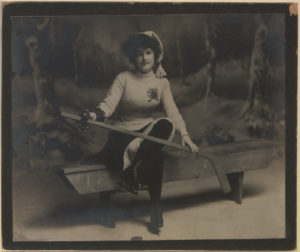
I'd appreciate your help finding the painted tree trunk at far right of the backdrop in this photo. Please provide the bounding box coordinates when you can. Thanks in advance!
[240,16,278,139]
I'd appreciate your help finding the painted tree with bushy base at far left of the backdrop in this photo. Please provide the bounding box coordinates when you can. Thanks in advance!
[20,18,86,169]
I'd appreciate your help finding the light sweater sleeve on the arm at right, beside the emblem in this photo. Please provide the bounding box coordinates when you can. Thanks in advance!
[161,79,188,136]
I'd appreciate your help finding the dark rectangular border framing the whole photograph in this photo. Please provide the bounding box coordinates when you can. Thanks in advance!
[2,2,298,250]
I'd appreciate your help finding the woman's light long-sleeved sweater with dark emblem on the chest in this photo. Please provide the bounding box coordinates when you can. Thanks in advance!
[98,71,187,135]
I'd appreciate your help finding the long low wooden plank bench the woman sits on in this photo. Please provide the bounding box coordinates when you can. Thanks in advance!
[63,140,280,204]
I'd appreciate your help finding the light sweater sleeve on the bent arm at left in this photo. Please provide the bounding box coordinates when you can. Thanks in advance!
[98,74,126,117]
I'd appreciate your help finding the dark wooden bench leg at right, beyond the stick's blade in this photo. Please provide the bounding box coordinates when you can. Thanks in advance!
[227,172,244,204]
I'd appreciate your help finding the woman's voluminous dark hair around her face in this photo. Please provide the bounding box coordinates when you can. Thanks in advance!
[122,34,160,63]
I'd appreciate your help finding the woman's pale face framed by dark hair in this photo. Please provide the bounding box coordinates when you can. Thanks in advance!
[135,47,154,73]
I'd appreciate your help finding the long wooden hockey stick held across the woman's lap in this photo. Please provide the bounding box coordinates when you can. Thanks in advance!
[61,112,231,193]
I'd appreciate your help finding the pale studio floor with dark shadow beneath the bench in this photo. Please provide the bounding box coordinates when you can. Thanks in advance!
[13,156,285,241]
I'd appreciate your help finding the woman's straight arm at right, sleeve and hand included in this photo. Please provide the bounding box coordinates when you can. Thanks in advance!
[161,79,198,154]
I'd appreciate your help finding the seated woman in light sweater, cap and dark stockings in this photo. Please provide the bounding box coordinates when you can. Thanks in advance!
[88,31,198,234]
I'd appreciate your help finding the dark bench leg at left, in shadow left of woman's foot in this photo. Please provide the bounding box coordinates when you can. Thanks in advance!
[99,191,115,228]
